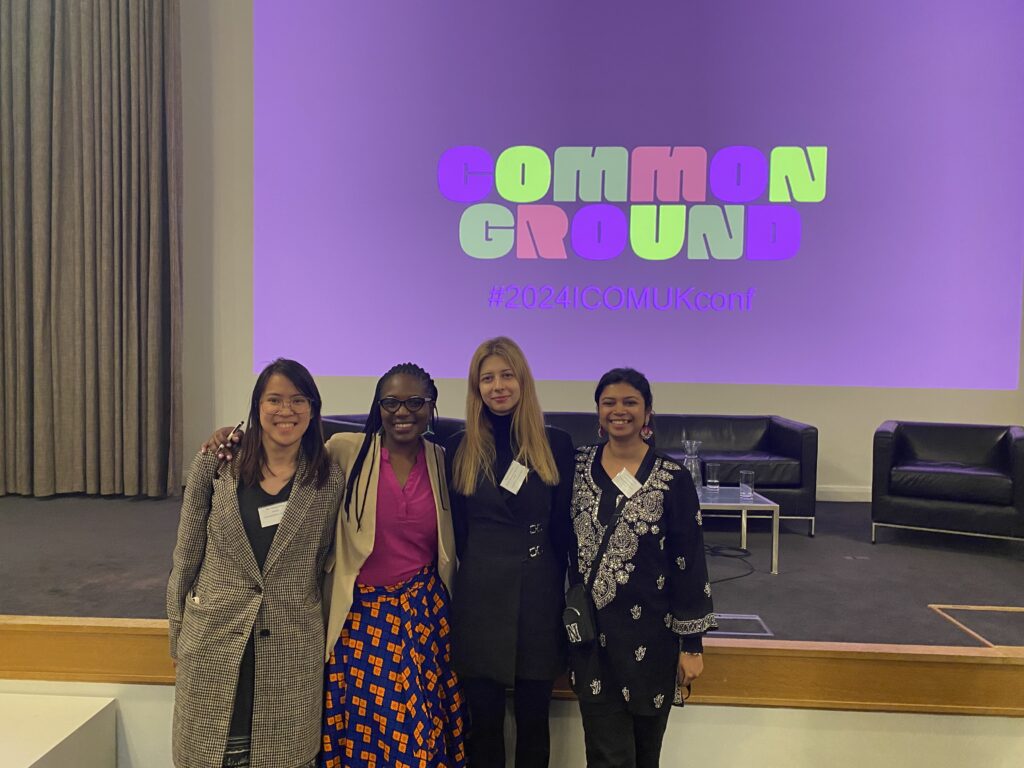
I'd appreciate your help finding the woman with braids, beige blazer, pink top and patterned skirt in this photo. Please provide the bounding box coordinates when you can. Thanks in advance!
[207,362,466,768]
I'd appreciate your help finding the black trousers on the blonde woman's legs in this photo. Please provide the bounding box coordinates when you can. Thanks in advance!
[462,678,555,768]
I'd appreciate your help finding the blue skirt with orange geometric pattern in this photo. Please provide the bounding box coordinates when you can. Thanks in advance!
[321,565,466,768]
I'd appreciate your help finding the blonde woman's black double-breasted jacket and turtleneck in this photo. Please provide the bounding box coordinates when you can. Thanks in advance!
[445,411,573,686]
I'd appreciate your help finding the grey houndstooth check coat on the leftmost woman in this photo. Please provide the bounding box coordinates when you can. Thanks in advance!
[167,454,344,768]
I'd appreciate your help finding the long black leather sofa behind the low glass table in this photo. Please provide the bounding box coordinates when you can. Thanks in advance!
[544,412,818,536]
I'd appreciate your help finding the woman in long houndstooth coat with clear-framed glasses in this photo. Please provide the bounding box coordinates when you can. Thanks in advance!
[167,359,344,768]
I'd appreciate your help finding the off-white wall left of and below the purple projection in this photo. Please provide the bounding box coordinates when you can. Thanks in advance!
[181,0,1024,500]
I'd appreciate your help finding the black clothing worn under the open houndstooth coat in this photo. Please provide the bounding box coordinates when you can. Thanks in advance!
[228,478,294,745]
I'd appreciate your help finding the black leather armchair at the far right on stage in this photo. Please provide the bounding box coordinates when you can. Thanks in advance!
[871,421,1024,543]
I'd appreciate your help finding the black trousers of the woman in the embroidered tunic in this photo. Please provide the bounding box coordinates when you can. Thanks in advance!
[580,701,671,768]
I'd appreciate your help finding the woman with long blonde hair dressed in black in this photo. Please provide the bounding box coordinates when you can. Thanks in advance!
[445,337,573,768]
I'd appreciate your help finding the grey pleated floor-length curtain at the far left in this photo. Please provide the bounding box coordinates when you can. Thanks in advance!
[0,0,181,496]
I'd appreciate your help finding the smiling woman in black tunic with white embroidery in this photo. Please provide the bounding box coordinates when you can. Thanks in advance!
[569,369,716,768]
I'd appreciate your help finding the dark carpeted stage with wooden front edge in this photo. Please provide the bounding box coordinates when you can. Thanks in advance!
[0,497,1024,717]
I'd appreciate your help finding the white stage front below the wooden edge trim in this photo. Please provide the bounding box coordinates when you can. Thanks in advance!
[0,680,1024,768]
